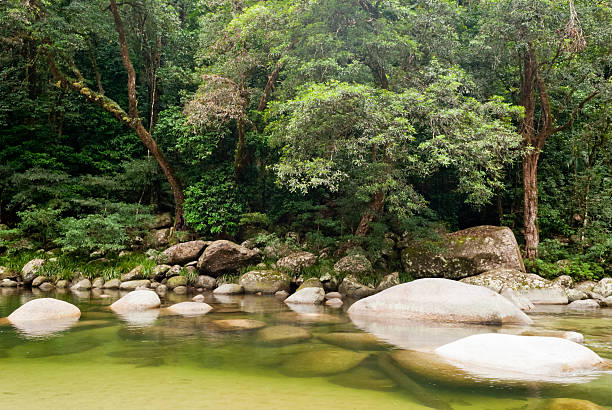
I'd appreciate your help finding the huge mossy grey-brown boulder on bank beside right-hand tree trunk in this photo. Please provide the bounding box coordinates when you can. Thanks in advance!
[402,226,525,279]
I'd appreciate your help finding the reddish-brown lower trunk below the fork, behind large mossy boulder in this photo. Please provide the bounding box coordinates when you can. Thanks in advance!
[523,151,540,260]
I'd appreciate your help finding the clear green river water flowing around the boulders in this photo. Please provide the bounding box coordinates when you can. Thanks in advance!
[0,288,612,410]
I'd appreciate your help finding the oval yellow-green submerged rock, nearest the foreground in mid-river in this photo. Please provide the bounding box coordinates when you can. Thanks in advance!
[281,349,368,377]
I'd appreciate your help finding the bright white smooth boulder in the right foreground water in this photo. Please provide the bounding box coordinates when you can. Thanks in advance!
[435,333,604,381]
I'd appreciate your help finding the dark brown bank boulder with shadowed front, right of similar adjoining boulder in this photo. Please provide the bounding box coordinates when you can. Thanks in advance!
[198,240,259,277]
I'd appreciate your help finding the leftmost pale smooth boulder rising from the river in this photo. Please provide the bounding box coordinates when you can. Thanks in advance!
[8,298,81,324]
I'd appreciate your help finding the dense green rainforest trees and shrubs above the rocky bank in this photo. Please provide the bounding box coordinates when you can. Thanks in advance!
[0,0,612,278]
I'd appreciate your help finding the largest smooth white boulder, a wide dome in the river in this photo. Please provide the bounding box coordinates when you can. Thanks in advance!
[348,278,532,324]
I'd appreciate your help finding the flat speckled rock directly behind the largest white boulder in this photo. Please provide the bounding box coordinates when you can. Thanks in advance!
[461,269,568,305]
